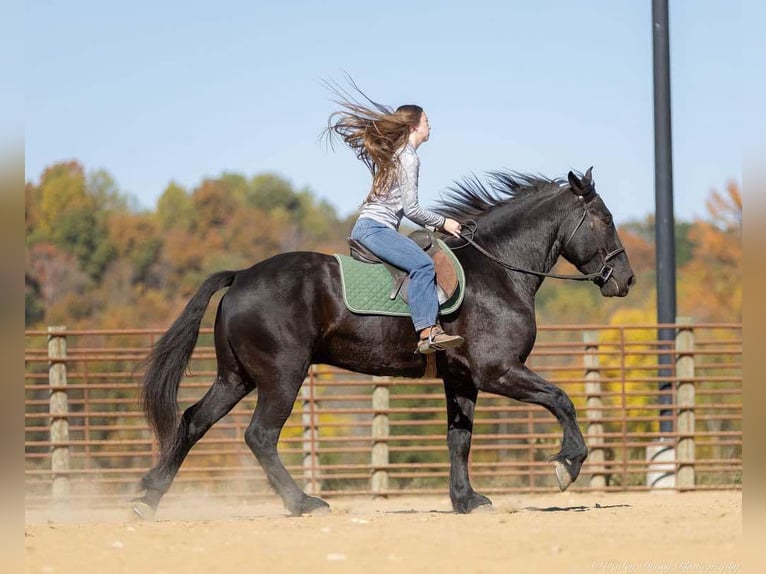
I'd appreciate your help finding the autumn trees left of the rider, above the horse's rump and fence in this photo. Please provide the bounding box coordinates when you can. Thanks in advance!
[25,162,351,329]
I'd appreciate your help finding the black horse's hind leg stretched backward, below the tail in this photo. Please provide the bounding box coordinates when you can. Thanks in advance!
[131,372,253,520]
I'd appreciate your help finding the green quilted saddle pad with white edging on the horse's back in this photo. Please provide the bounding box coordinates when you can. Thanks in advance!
[335,239,465,317]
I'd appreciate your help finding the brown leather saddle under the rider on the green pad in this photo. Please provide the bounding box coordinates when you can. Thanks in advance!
[348,229,458,304]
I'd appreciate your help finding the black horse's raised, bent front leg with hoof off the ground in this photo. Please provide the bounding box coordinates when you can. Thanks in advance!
[481,364,588,491]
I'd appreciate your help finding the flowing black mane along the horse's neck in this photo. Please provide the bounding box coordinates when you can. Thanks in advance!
[432,171,568,221]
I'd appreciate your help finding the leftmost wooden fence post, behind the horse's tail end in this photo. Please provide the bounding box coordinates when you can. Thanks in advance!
[48,326,70,502]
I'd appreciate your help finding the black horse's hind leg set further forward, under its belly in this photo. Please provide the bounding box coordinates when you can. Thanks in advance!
[245,362,330,516]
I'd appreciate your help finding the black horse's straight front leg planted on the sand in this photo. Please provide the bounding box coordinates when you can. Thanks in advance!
[444,379,492,514]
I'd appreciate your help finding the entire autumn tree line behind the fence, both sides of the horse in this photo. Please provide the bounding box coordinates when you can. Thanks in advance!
[25,161,742,329]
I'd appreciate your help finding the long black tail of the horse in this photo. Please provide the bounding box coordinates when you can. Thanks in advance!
[141,271,237,460]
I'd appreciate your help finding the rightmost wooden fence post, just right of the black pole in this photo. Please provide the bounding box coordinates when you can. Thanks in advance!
[676,317,695,490]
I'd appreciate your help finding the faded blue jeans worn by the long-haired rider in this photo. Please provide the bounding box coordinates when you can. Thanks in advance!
[351,217,439,331]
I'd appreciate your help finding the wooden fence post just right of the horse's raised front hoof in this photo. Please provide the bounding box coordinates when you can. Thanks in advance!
[583,331,606,489]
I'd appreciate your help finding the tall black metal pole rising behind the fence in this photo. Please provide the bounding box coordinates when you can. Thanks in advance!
[652,0,676,433]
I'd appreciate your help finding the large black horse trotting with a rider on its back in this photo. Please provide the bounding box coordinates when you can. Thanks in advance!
[132,169,635,518]
